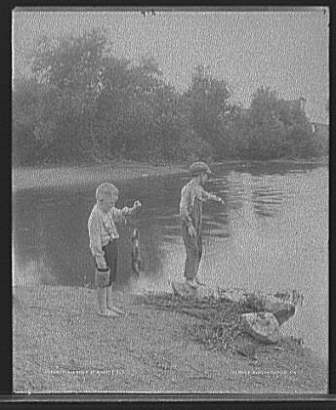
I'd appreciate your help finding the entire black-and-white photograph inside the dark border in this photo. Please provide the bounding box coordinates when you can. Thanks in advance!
[11,7,329,398]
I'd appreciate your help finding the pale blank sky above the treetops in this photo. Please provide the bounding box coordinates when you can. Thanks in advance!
[12,7,329,123]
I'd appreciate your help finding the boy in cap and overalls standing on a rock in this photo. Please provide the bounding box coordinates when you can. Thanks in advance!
[180,161,224,288]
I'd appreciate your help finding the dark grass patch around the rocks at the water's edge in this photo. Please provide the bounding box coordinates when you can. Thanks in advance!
[137,293,302,356]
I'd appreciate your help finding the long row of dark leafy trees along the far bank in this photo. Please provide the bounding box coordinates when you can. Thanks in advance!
[12,30,325,166]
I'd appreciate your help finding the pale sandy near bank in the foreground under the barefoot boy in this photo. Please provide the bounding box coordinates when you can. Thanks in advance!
[13,286,328,393]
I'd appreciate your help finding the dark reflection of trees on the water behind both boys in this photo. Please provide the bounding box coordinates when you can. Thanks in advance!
[13,164,326,285]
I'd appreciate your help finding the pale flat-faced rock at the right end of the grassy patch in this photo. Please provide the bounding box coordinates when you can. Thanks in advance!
[241,312,280,343]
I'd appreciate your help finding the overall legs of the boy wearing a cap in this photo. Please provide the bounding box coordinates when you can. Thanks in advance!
[182,224,202,280]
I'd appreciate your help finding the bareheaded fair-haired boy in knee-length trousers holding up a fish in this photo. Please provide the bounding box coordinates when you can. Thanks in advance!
[88,182,141,317]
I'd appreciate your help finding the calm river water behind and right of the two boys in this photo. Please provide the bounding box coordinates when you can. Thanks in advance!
[13,163,328,357]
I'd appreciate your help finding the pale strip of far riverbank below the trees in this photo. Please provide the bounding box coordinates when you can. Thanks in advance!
[12,158,328,192]
